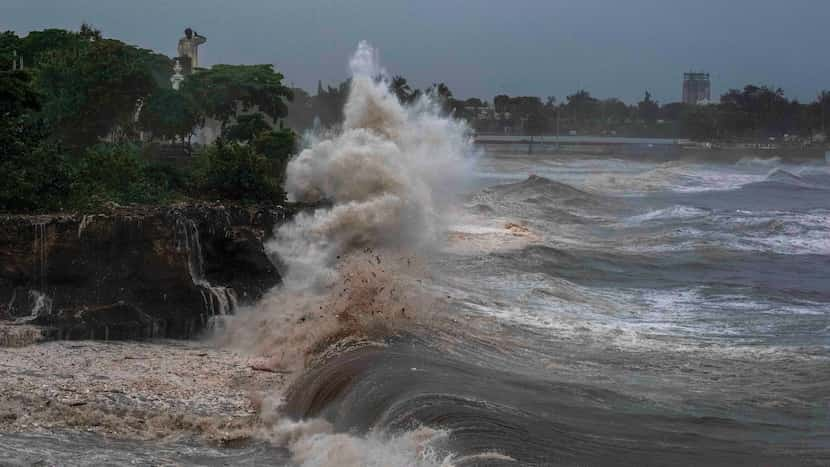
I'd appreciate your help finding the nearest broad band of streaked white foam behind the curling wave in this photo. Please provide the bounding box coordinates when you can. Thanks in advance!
[442,264,830,355]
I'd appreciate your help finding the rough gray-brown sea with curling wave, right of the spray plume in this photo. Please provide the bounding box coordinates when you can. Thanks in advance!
[0,154,830,466]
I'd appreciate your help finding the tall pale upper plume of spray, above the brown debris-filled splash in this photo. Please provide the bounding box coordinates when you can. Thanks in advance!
[269,42,471,288]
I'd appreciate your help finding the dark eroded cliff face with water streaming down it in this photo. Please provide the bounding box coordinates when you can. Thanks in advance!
[0,203,292,339]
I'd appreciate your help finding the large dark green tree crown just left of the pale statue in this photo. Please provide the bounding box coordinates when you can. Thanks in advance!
[15,26,172,149]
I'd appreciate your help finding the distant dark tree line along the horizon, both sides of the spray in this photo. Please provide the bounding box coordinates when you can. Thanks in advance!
[286,71,830,141]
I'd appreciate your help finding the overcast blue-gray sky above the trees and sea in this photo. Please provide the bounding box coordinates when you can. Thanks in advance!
[6,0,830,102]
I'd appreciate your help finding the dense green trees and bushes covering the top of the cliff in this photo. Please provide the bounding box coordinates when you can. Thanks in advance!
[0,25,296,211]
